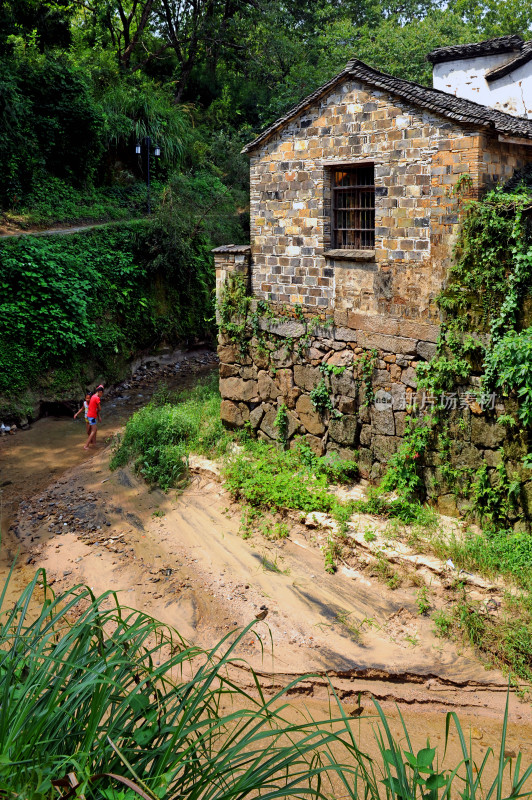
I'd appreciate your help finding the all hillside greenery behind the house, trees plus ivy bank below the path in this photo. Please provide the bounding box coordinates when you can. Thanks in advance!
[0,0,532,404]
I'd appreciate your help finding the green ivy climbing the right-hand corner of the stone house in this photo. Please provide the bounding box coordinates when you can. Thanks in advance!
[381,187,532,512]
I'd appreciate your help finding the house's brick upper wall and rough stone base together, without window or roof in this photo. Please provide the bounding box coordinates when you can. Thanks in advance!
[215,80,532,517]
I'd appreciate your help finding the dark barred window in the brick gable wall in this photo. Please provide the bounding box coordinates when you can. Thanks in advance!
[332,164,375,250]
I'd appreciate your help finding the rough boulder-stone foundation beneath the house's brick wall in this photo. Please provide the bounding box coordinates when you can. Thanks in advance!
[218,314,532,524]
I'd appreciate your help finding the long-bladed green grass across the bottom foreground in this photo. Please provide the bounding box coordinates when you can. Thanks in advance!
[0,571,532,800]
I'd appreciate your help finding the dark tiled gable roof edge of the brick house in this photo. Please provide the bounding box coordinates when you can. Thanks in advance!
[242,59,532,153]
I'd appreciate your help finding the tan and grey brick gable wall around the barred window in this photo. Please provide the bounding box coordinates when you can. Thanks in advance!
[251,81,486,321]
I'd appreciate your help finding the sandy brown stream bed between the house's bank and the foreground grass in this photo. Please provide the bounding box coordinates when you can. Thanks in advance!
[0,354,532,757]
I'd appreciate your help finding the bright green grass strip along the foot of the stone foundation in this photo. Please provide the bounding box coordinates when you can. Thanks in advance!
[114,382,358,571]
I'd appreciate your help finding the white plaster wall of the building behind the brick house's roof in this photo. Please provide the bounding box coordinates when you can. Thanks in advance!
[433,53,532,119]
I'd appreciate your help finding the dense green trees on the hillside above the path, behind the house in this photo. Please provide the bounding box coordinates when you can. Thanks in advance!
[0,0,532,214]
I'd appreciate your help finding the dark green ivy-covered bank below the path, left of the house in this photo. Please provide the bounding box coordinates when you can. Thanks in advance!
[0,214,216,406]
